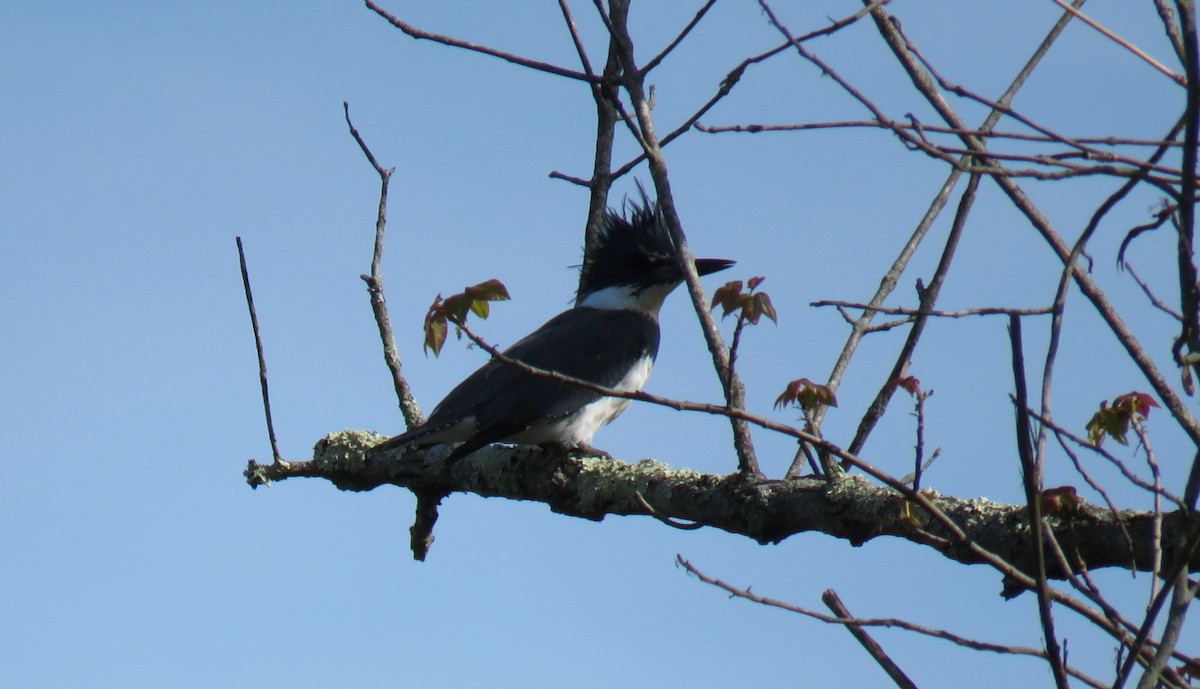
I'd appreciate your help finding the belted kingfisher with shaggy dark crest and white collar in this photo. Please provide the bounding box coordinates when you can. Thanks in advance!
[372,193,734,461]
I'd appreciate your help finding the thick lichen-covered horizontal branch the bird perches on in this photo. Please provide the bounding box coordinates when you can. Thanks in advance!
[245,431,1200,579]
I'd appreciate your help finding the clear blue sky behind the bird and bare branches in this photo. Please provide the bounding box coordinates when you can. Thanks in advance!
[0,0,1195,689]
